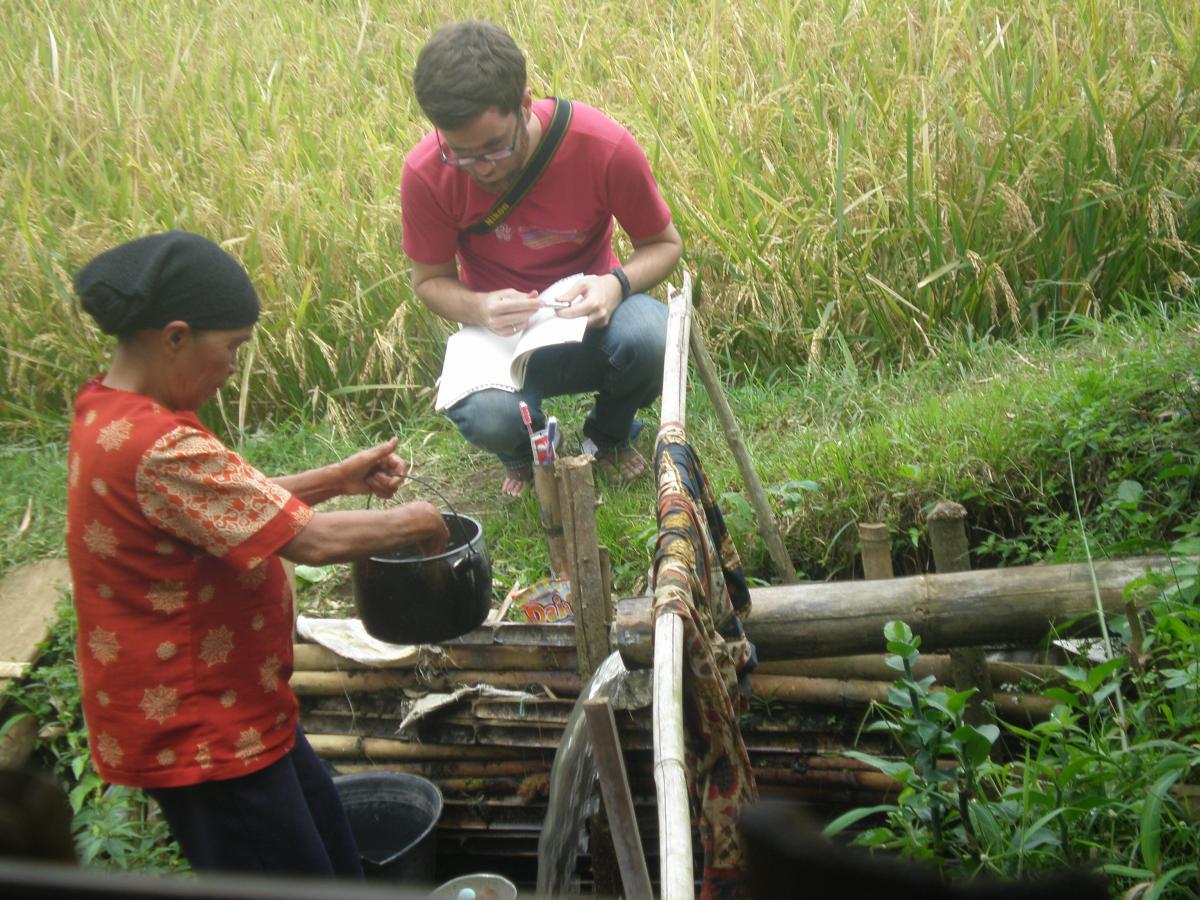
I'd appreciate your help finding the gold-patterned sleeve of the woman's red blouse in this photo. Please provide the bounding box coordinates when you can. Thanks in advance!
[136,426,292,558]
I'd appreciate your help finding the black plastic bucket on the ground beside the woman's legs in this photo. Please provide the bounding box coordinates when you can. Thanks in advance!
[334,772,442,884]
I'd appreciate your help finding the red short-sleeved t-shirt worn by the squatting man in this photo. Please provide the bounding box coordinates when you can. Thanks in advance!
[401,98,671,290]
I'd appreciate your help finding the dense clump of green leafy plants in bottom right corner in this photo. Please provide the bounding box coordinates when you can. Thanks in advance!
[827,532,1200,898]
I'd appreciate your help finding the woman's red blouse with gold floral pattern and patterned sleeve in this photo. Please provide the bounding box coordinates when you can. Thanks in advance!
[67,380,313,787]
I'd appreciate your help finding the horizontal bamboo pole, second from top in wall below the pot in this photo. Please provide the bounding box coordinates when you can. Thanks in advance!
[285,668,580,697]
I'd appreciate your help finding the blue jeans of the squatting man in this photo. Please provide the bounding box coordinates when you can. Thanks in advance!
[446,294,667,469]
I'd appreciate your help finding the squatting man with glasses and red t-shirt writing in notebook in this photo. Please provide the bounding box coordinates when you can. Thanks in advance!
[401,22,683,496]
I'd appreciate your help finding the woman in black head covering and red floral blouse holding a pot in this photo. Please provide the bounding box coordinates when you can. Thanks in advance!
[67,232,448,876]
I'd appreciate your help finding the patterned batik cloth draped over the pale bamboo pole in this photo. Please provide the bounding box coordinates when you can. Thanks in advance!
[654,426,757,898]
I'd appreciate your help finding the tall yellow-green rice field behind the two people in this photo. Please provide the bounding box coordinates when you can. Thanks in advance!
[0,0,1200,432]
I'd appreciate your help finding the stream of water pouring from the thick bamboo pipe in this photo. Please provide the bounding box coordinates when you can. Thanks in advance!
[538,653,652,896]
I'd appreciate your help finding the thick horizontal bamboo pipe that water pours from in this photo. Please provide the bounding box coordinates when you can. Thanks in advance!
[613,557,1170,668]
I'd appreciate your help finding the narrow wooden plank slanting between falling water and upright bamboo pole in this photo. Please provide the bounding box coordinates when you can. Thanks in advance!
[583,698,654,900]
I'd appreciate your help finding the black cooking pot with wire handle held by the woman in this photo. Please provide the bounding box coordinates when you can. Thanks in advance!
[354,512,492,643]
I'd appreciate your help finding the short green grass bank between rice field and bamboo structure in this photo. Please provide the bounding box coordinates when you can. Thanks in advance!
[0,310,1200,596]
